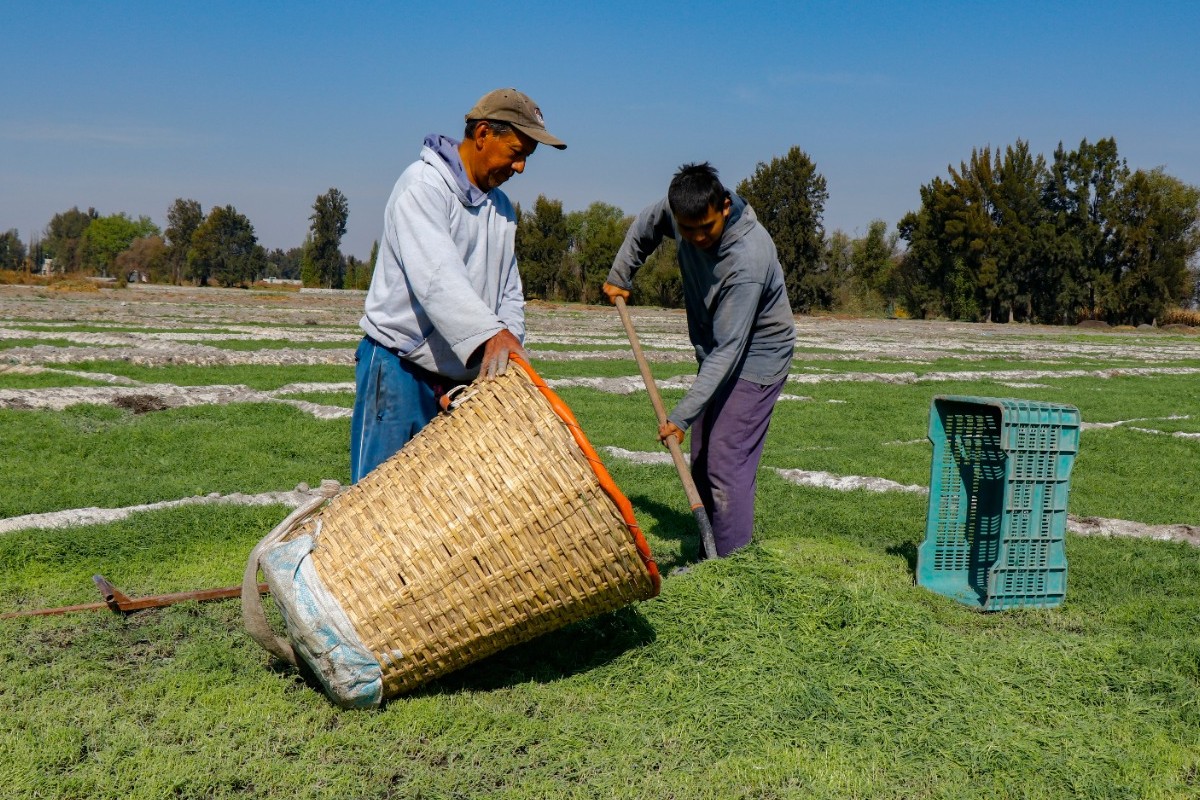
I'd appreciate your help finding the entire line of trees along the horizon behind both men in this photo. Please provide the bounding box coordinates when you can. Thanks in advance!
[0,138,1200,324]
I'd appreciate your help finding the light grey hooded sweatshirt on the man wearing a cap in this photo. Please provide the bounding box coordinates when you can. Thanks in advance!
[359,136,524,380]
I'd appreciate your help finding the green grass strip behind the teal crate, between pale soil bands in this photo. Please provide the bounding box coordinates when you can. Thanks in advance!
[558,375,1200,524]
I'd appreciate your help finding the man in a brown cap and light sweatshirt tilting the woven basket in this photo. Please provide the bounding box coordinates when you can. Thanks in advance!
[350,89,566,483]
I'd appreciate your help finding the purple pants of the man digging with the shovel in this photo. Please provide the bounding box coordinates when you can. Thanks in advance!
[691,378,787,558]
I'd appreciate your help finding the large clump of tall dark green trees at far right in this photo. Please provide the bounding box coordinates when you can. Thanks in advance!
[894,139,1200,325]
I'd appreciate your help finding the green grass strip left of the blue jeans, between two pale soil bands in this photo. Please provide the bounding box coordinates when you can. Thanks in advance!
[0,403,349,517]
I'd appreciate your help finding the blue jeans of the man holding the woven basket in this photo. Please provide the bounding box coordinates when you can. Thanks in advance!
[350,337,443,483]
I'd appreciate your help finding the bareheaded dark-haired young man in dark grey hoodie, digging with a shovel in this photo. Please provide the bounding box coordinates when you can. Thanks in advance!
[604,163,796,555]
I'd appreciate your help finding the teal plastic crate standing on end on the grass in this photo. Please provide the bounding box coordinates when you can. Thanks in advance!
[917,396,1080,612]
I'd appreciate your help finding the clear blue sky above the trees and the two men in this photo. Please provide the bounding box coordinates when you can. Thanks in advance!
[0,0,1200,258]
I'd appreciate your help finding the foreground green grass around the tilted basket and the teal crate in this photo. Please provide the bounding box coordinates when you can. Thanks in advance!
[0,496,1200,798]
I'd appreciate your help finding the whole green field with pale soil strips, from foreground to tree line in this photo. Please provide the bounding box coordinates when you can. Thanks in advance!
[0,287,1200,800]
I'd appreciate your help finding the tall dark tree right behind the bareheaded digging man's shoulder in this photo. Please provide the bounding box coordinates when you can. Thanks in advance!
[737,146,833,311]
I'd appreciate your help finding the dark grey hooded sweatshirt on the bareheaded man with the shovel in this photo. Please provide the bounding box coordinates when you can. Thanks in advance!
[607,194,796,431]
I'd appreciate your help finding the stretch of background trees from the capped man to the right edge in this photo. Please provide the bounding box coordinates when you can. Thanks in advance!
[517,139,1200,325]
